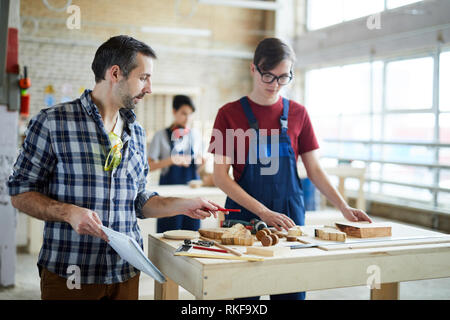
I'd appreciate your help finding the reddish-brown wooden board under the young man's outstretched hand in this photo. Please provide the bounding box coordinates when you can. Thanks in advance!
[336,222,392,238]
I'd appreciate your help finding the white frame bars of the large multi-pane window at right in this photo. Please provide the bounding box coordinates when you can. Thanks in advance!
[304,45,450,213]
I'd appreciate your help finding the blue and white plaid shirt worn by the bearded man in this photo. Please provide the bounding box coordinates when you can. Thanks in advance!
[8,90,157,284]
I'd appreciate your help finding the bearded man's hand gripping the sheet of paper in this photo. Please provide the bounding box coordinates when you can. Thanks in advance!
[66,206,109,242]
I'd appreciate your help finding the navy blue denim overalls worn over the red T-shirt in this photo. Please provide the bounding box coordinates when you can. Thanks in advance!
[225,97,305,300]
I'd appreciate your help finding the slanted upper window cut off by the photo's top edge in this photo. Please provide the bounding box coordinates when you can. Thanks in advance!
[307,0,419,30]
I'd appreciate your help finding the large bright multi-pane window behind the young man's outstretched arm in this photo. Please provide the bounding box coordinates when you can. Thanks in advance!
[305,52,450,210]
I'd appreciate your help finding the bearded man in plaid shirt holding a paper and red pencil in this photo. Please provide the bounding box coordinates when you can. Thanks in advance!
[8,36,218,299]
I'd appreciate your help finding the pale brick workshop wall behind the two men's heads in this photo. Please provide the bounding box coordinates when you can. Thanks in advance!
[19,0,267,142]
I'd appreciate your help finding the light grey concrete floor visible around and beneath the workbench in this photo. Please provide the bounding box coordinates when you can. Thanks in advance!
[0,254,450,300]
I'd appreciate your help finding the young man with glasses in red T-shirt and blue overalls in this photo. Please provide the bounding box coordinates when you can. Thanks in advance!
[209,38,371,300]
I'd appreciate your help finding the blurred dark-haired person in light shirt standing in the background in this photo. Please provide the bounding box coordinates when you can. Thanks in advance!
[148,95,203,233]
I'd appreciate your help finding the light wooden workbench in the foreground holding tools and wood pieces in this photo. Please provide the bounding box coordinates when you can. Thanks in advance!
[148,223,450,299]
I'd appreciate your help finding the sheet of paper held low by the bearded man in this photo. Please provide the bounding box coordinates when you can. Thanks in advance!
[102,226,166,283]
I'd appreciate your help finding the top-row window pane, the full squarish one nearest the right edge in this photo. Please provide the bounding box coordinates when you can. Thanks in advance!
[386,57,433,109]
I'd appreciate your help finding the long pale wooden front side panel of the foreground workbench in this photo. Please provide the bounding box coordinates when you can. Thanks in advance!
[203,245,450,299]
